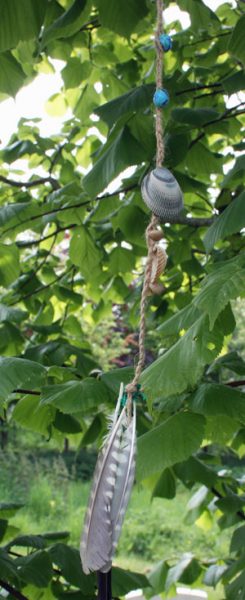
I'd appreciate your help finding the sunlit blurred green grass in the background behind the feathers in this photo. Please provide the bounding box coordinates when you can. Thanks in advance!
[0,456,229,600]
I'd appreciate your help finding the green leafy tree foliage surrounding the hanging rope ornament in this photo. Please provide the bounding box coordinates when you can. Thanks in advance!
[0,0,245,600]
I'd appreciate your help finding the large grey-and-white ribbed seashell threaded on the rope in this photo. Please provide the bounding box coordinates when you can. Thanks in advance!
[141,167,183,223]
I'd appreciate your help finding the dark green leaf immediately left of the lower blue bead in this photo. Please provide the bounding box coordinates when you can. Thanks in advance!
[95,83,155,127]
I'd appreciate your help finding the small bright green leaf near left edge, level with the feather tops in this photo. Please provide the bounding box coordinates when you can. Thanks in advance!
[12,394,55,435]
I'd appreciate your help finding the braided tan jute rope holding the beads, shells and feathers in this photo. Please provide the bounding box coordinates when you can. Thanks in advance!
[126,0,164,408]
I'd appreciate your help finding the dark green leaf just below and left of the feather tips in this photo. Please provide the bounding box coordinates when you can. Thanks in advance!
[49,544,95,596]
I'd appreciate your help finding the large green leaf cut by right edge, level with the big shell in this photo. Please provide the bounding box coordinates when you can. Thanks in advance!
[203,192,245,252]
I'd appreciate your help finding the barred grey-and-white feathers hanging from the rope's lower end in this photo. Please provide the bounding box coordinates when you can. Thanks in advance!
[80,384,136,574]
